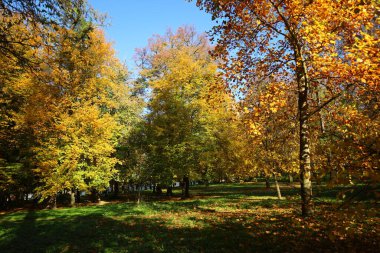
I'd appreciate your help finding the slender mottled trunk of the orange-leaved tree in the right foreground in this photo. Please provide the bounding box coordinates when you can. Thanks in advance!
[296,46,313,217]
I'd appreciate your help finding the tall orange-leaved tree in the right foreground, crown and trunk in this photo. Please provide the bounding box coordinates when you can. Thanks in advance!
[197,0,379,216]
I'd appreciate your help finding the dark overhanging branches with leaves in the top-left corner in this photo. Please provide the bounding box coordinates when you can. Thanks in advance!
[0,0,102,64]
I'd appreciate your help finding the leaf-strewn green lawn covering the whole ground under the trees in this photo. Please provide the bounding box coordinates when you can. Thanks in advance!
[0,183,380,253]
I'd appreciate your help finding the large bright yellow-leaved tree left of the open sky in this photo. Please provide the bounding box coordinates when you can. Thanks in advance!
[6,24,134,205]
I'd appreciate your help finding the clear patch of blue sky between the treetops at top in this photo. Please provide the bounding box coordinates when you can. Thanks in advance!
[88,0,214,70]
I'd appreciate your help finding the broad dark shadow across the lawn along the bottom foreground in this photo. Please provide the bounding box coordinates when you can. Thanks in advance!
[0,208,376,253]
